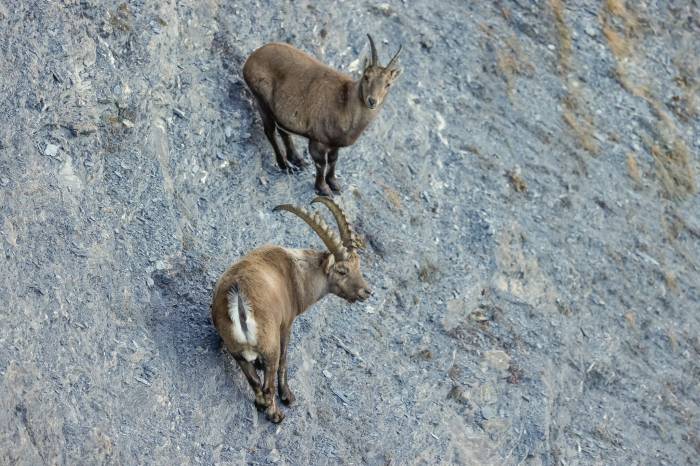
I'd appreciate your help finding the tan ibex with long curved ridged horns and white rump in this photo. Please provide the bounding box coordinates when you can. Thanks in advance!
[212,197,372,423]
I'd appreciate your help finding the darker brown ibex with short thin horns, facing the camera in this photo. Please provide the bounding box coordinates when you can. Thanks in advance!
[243,34,401,196]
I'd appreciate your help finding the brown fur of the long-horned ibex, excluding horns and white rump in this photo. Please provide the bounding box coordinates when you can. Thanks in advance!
[212,246,371,422]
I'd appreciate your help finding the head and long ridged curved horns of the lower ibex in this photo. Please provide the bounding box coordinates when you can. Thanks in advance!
[273,197,372,303]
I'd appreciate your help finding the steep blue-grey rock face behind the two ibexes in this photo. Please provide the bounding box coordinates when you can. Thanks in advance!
[0,0,700,465]
